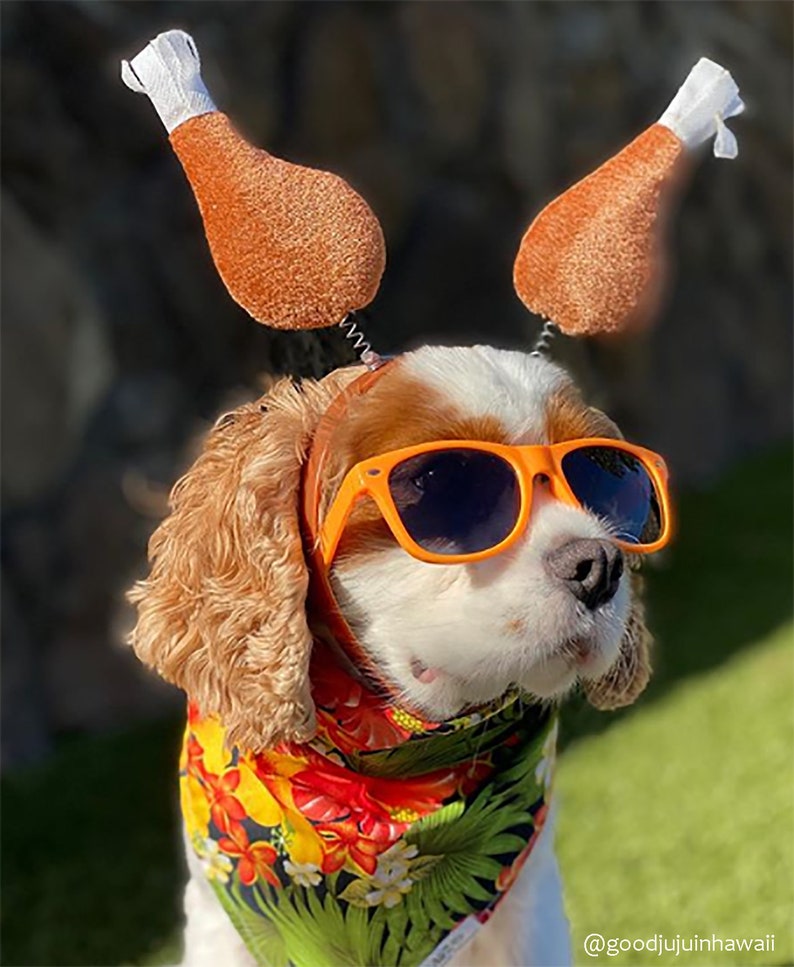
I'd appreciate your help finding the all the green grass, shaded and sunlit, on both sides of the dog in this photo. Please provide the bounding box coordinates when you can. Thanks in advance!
[0,450,794,967]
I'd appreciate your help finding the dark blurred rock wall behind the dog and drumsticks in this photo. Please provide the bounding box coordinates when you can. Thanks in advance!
[0,0,792,766]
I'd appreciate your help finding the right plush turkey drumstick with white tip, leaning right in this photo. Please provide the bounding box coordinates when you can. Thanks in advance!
[513,58,744,336]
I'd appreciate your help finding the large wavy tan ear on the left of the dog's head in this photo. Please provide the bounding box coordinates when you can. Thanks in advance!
[129,368,360,751]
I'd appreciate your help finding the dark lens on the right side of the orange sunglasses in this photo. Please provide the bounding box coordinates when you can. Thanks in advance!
[562,447,662,544]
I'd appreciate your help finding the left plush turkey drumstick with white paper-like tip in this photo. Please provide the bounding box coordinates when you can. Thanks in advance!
[122,30,386,329]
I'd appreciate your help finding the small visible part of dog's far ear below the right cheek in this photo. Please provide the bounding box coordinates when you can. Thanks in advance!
[584,571,653,711]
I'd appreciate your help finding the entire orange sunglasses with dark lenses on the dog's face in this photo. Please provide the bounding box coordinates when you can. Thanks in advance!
[319,437,671,566]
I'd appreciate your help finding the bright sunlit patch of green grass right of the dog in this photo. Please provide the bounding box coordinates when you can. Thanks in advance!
[557,624,794,965]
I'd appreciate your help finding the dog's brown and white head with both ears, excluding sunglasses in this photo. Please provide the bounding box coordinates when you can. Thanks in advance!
[131,347,649,749]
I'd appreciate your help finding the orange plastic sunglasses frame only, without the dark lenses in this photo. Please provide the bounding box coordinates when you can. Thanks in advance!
[318,437,672,567]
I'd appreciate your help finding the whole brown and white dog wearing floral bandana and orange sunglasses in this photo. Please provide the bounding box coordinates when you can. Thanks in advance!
[125,346,658,967]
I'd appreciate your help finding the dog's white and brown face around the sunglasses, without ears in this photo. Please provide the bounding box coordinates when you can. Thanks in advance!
[321,347,632,718]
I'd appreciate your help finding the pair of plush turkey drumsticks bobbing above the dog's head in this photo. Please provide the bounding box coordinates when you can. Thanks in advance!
[122,30,744,352]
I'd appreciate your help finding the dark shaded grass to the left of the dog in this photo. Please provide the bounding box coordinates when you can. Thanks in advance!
[0,723,184,965]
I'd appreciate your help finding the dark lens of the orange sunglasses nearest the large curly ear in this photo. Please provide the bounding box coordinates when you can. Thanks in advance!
[389,447,521,554]
